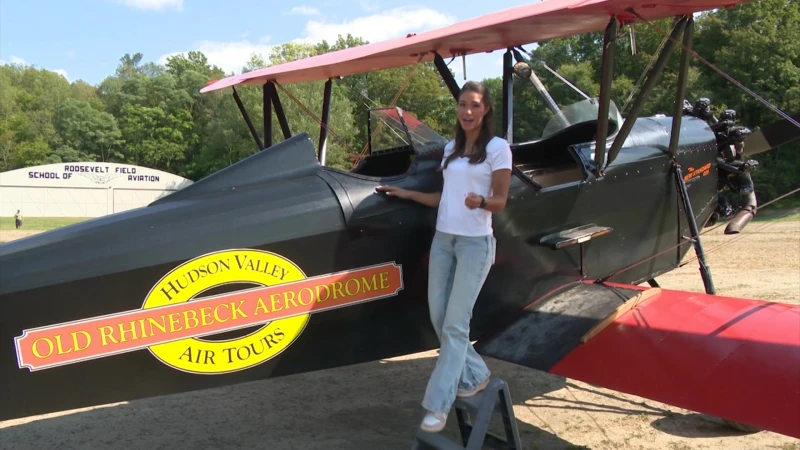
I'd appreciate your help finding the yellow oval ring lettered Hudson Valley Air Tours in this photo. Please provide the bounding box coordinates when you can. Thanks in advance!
[142,250,309,374]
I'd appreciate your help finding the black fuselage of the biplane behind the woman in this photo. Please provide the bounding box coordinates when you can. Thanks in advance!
[0,96,718,419]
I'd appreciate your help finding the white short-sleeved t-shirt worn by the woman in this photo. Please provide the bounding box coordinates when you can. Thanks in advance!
[436,137,511,236]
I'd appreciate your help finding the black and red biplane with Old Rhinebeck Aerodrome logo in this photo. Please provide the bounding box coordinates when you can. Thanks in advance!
[0,0,800,437]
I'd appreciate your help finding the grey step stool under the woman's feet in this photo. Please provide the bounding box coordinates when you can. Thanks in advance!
[411,378,522,450]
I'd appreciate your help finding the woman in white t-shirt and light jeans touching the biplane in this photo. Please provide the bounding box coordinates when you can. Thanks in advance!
[378,81,511,432]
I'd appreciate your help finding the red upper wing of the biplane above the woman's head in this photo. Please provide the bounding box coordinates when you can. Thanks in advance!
[200,0,750,92]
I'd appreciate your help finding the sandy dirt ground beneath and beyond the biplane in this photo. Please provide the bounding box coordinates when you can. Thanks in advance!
[0,216,800,450]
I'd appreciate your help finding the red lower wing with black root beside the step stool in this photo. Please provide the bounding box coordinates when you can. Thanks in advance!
[475,283,800,438]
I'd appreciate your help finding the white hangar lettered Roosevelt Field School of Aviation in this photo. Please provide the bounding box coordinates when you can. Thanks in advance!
[0,162,192,217]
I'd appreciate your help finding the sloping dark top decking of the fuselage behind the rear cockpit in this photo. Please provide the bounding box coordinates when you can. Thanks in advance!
[0,134,344,298]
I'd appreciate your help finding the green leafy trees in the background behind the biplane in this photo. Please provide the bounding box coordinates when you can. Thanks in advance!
[0,0,800,203]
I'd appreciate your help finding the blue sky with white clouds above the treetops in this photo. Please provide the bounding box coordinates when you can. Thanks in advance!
[0,0,530,85]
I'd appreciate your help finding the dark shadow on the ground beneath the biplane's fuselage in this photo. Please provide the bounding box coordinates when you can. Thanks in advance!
[0,353,576,450]
